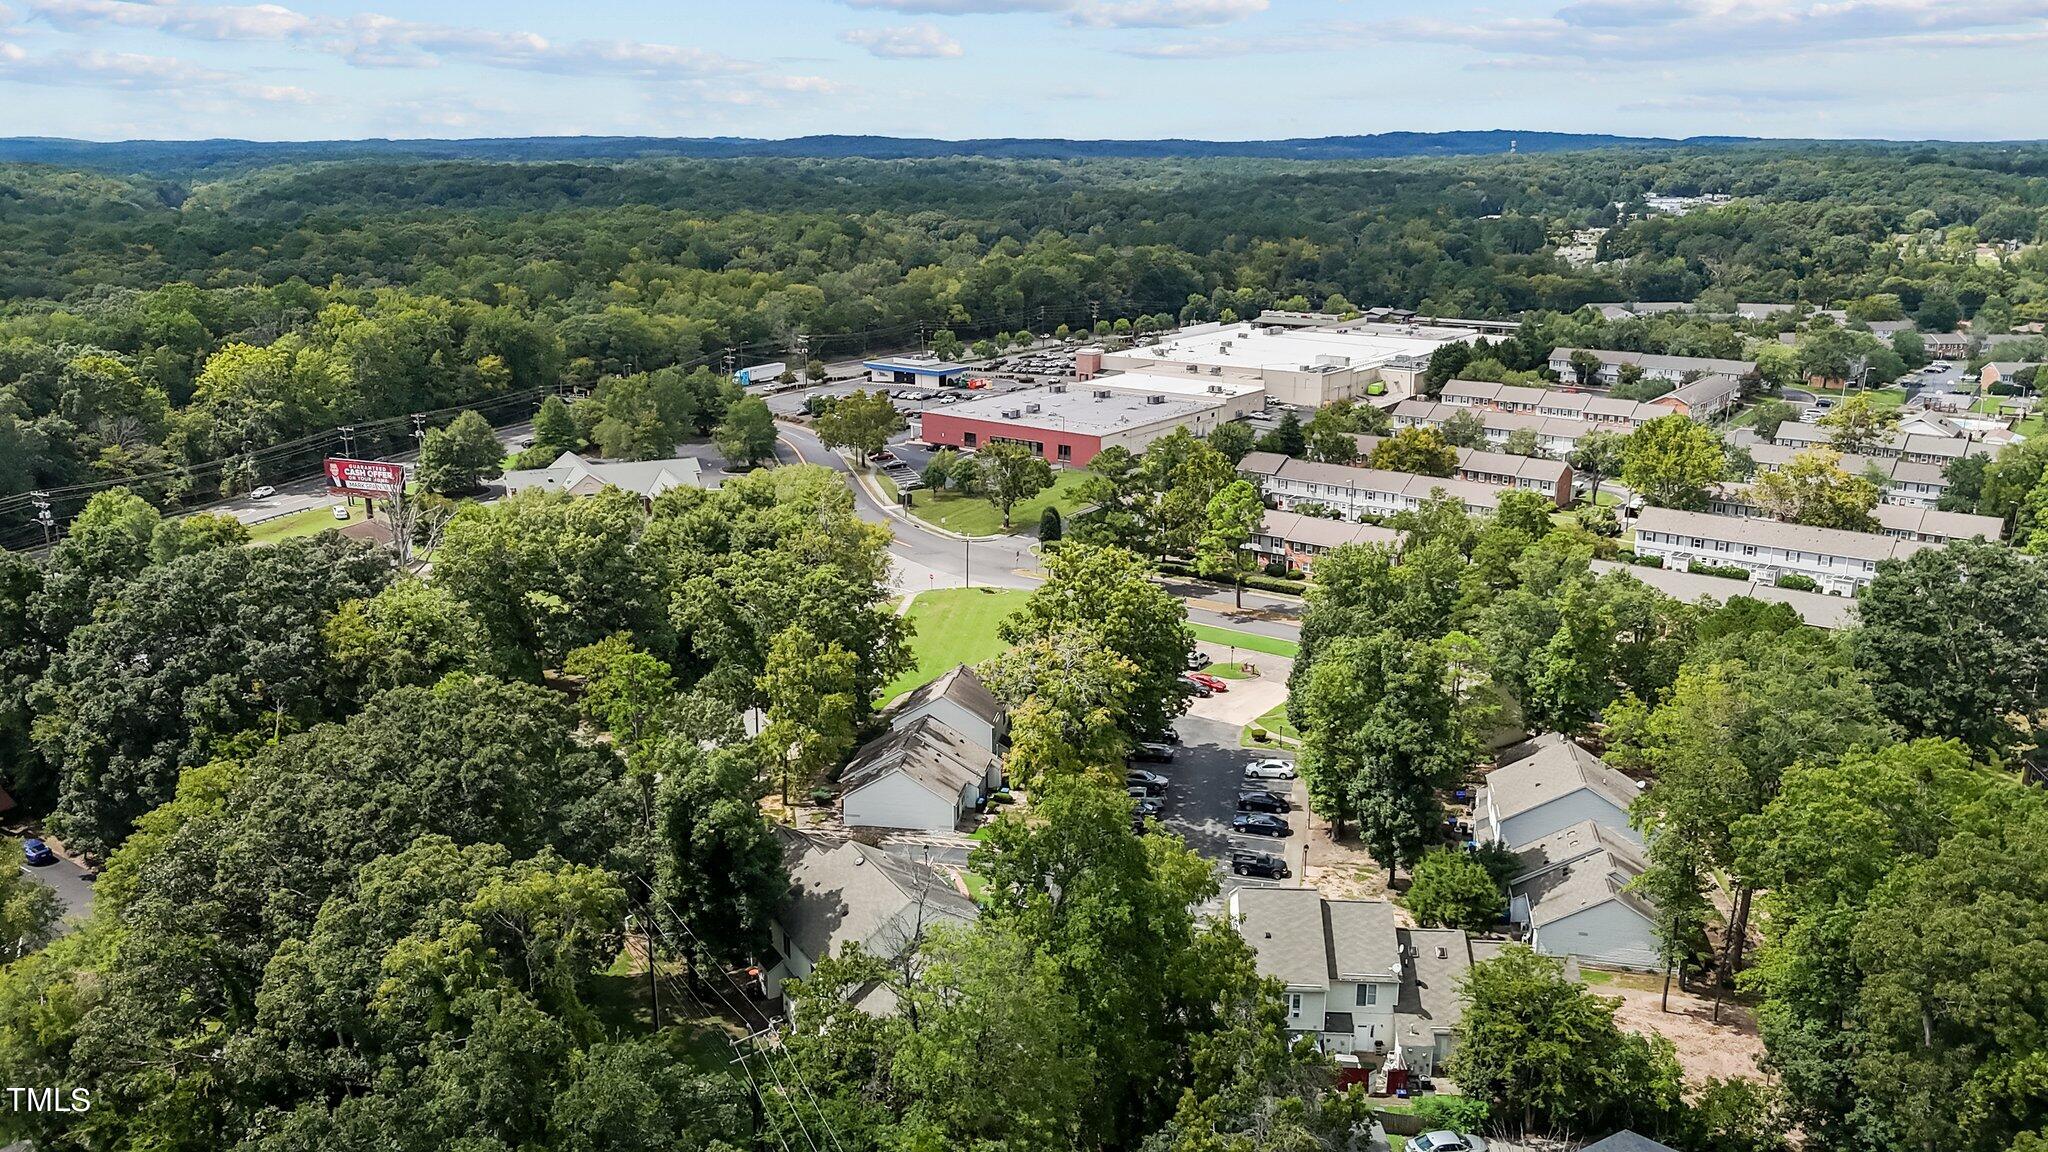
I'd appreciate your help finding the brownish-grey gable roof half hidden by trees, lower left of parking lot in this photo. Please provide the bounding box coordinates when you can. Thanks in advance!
[776,828,979,963]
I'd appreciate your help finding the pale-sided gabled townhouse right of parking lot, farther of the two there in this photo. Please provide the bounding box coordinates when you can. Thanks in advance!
[1473,732,1638,851]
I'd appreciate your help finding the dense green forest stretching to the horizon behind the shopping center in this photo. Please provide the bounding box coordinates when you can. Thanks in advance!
[12,148,2048,545]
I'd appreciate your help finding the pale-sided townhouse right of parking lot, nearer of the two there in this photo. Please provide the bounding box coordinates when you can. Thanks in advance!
[1507,820,1661,970]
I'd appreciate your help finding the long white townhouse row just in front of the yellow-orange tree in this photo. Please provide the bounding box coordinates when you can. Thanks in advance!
[1636,508,1933,596]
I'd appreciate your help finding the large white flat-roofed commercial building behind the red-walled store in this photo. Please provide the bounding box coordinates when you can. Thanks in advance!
[1077,320,1475,408]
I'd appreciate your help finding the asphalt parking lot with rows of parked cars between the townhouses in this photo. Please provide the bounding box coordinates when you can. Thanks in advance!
[1137,715,1309,890]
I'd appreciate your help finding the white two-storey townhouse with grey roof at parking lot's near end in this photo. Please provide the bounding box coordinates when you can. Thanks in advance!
[1229,888,1403,1056]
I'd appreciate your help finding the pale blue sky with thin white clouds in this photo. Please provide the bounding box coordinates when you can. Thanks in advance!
[0,0,2048,139]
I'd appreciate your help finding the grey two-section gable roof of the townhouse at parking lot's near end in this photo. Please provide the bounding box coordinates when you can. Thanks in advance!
[1231,888,1401,988]
